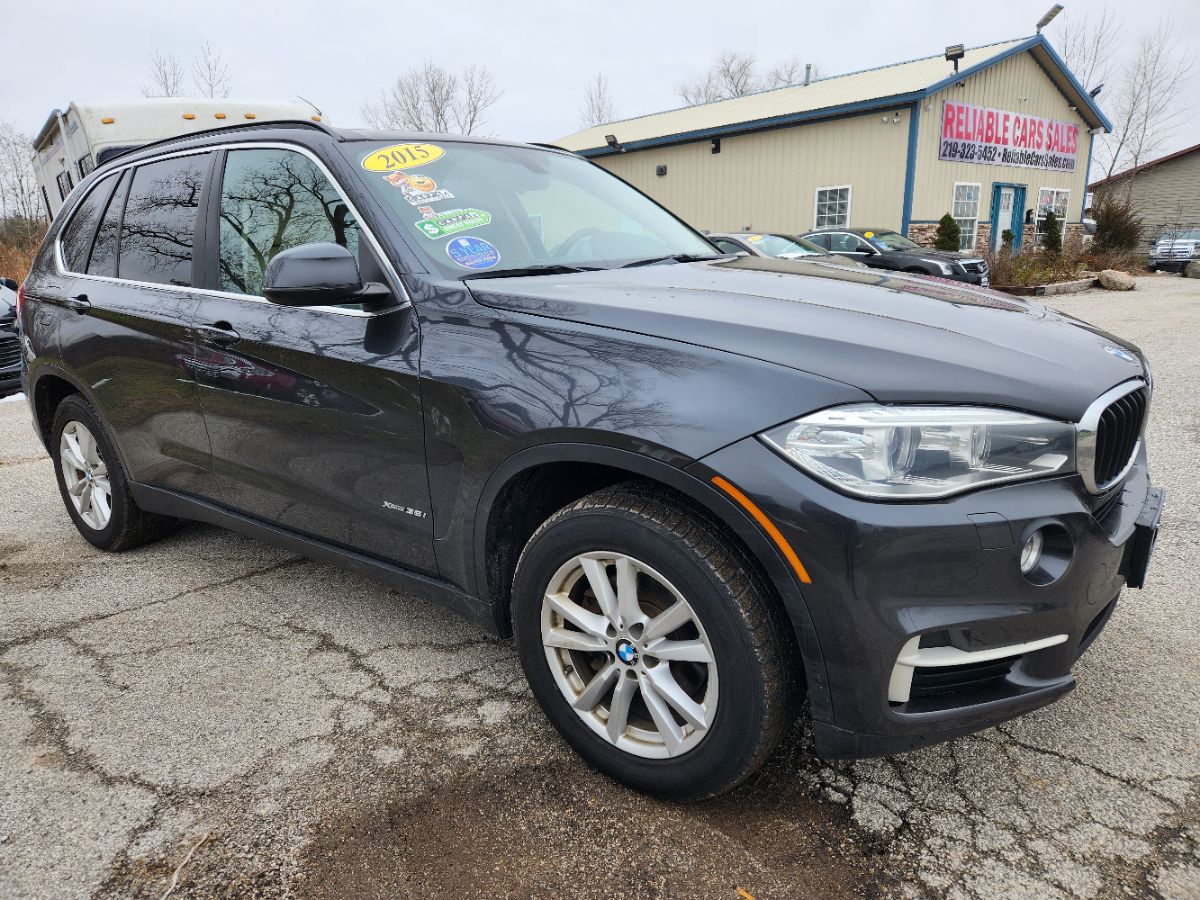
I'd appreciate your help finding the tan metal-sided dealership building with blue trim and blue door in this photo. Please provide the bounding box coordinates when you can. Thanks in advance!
[556,35,1110,251]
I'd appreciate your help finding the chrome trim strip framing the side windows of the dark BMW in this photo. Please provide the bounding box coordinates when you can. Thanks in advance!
[54,140,413,318]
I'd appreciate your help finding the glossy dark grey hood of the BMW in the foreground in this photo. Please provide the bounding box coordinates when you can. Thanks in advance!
[467,257,1144,420]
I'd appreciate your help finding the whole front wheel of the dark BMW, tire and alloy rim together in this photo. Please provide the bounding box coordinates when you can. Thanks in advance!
[512,482,798,800]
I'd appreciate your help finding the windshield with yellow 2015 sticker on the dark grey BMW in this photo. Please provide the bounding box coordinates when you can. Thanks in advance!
[343,140,720,277]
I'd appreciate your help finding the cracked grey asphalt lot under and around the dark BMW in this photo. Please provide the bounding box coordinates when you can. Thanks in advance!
[0,276,1200,899]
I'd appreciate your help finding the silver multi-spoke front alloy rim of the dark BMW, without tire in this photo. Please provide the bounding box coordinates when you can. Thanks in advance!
[541,552,718,758]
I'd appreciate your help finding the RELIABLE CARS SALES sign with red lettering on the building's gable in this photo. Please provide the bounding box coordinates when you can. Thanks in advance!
[937,100,1079,172]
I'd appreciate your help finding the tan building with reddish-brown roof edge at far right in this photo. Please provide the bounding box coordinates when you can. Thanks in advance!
[1091,144,1200,241]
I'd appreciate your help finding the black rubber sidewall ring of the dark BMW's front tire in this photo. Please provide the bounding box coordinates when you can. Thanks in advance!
[512,509,767,797]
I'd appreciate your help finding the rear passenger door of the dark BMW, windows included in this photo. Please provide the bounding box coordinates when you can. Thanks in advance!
[55,152,214,496]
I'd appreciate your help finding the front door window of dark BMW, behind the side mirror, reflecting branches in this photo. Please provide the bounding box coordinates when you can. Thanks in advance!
[218,149,359,296]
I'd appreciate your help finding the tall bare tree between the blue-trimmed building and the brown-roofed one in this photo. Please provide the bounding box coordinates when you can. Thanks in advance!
[1096,23,1196,184]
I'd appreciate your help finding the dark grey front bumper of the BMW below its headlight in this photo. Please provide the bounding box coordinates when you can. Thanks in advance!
[692,438,1151,757]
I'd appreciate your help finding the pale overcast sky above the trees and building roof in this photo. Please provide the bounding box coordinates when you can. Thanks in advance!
[0,0,1200,164]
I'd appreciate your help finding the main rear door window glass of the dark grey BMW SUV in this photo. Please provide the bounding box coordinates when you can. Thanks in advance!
[120,154,209,288]
